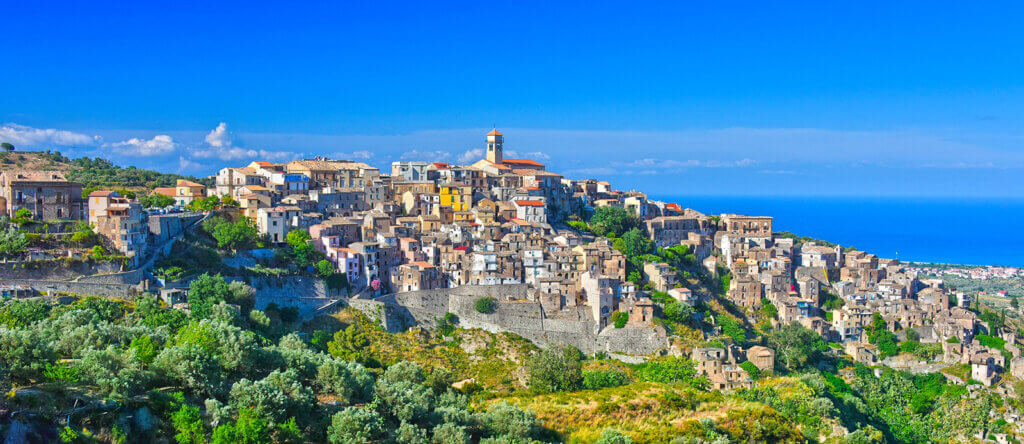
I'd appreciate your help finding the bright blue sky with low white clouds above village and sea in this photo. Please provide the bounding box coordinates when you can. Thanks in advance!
[0,1,1024,196]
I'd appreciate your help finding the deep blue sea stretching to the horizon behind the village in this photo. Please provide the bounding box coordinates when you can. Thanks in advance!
[650,195,1024,266]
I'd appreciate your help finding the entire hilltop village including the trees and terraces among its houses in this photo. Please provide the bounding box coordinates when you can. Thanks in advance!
[0,130,1024,439]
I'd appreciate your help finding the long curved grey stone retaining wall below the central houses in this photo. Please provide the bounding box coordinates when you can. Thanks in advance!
[360,284,669,356]
